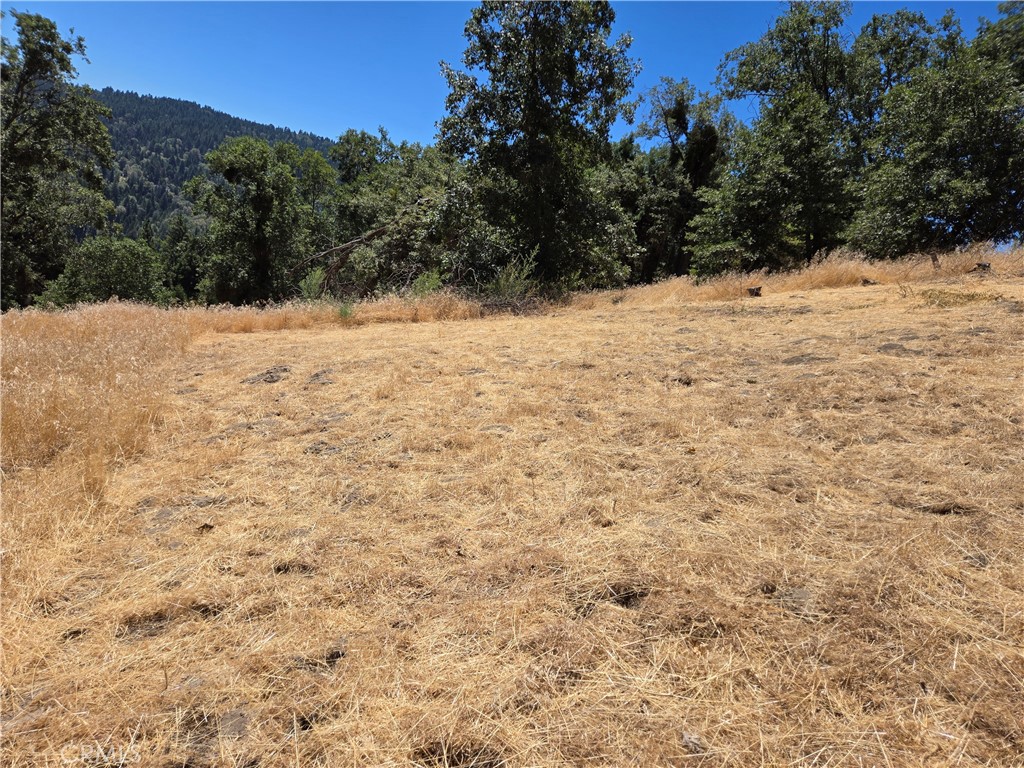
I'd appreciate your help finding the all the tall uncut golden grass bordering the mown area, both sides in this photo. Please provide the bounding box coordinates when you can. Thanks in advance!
[0,246,1024,483]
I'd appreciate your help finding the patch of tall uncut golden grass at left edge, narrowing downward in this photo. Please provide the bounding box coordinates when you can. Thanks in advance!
[0,302,191,675]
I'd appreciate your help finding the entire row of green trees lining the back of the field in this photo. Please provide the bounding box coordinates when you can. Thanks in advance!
[0,0,1024,309]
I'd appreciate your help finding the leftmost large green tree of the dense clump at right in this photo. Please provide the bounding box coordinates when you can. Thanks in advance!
[691,2,854,274]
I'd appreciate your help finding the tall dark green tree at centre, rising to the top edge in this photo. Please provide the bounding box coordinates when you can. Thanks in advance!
[440,1,638,285]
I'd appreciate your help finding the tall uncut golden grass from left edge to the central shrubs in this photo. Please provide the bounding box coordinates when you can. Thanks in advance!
[0,292,481,469]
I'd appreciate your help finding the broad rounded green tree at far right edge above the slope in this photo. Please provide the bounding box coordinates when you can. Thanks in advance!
[851,47,1024,256]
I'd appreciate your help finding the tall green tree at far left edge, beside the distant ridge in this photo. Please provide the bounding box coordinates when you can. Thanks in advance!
[0,11,112,309]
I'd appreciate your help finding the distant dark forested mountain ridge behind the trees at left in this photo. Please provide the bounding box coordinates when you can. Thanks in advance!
[93,88,334,237]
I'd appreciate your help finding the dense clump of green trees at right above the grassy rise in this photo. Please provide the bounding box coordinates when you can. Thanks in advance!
[690,2,1024,275]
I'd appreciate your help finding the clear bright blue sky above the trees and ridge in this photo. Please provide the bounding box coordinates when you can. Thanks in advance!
[3,0,998,143]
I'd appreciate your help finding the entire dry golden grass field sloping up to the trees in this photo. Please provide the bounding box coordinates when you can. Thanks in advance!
[6,250,1024,768]
